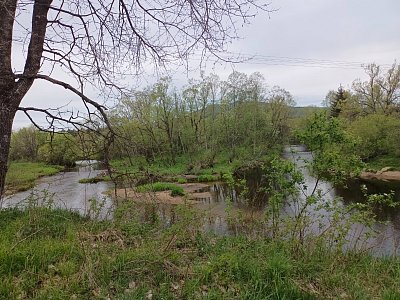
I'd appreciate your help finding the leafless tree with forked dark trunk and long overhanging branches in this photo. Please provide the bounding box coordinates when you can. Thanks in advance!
[0,0,269,195]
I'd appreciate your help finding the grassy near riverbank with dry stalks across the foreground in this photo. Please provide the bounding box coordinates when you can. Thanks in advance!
[0,205,400,299]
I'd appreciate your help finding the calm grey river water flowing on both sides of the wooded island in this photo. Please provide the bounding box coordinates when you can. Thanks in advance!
[2,150,400,256]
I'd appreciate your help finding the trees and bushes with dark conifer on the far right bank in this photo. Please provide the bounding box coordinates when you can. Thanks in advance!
[326,62,400,161]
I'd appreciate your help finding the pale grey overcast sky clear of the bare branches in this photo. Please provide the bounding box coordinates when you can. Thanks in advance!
[13,0,400,128]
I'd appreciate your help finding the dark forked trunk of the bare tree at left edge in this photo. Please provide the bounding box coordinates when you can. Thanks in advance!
[0,0,52,199]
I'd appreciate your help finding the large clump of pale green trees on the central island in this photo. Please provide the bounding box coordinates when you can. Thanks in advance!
[110,72,294,165]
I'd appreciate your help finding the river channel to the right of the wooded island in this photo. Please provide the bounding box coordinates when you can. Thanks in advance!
[284,145,400,256]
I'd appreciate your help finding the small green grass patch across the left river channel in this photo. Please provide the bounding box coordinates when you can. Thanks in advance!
[6,162,64,192]
